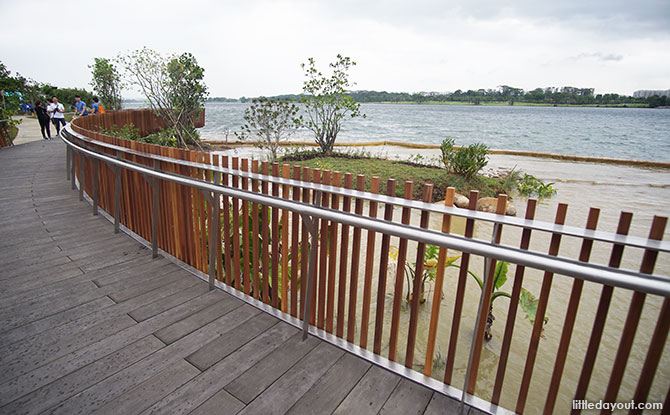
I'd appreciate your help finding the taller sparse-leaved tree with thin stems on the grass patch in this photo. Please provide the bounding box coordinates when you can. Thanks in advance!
[301,54,365,153]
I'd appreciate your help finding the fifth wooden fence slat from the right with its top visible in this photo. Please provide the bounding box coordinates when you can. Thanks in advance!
[491,199,537,405]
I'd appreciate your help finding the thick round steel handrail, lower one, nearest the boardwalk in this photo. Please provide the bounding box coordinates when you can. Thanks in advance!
[62,127,670,297]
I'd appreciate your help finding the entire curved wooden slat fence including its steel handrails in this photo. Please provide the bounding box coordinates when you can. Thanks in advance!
[63,110,670,413]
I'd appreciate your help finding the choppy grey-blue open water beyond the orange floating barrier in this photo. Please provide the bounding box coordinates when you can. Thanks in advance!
[192,102,670,161]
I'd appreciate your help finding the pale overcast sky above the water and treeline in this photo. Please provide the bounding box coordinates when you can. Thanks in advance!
[0,0,670,98]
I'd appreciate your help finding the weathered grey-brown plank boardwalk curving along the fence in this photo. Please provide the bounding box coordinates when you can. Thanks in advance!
[0,140,479,415]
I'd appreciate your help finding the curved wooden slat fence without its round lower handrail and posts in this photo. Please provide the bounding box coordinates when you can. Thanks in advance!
[65,110,670,413]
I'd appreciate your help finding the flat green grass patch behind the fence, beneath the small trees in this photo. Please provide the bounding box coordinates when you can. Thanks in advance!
[280,151,512,202]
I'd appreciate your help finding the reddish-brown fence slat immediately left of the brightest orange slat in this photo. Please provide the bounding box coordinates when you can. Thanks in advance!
[405,183,433,369]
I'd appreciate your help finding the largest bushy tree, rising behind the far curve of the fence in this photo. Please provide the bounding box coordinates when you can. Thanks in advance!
[118,47,207,147]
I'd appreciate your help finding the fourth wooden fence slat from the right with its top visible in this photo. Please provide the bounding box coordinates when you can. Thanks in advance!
[516,203,568,413]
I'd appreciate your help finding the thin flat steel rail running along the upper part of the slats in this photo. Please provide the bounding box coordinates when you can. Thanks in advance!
[68,126,670,252]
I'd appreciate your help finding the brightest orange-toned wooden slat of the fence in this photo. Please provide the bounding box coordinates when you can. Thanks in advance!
[423,187,456,376]
